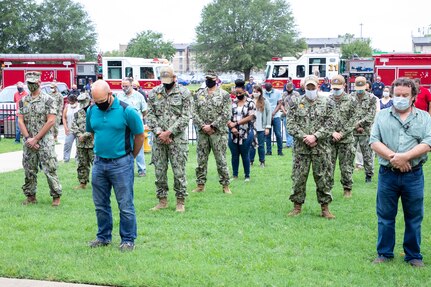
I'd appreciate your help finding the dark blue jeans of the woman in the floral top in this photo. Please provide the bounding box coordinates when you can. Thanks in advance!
[228,130,254,178]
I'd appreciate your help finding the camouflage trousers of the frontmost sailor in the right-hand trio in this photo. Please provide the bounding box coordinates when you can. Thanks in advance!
[289,153,332,204]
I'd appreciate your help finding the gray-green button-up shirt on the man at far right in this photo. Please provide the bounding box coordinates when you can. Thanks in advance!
[370,107,431,167]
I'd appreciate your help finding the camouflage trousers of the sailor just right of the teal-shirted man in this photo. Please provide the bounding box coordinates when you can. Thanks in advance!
[151,139,189,198]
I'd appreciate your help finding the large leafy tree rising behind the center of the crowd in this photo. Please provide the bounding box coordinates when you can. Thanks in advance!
[193,0,306,79]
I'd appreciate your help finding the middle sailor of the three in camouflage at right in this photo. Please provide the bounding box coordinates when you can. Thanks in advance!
[329,75,356,197]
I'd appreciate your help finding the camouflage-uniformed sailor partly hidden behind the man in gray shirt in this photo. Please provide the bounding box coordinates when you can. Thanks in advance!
[351,77,377,182]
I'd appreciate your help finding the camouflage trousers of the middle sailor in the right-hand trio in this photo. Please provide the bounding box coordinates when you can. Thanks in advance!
[331,143,356,190]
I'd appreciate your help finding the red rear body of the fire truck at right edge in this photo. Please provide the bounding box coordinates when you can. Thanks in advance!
[373,53,431,88]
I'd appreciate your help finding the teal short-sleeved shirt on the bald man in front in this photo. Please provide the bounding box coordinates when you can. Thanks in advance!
[86,98,144,159]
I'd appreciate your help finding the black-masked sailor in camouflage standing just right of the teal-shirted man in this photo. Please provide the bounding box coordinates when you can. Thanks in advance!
[147,67,193,212]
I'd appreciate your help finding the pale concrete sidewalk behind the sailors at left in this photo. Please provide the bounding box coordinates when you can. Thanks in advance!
[0,125,76,172]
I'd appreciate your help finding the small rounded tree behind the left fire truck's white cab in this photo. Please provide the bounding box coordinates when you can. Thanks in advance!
[125,30,176,60]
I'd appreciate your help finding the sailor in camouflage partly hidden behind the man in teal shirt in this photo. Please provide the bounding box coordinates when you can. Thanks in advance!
[70,93,94,189]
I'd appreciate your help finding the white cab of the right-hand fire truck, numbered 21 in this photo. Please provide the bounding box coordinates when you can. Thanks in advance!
[265,53,340,89]
